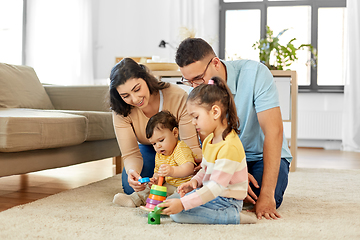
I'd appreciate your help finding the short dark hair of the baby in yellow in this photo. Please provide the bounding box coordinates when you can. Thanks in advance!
[146,110,179,139]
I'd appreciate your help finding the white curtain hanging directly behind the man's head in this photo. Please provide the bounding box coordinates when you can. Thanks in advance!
[169,0,219,52]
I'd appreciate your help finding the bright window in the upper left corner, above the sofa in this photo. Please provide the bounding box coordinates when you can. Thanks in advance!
[0,0,23,65]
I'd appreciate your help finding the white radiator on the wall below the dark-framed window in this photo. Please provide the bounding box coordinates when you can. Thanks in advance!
[298,111,343,140]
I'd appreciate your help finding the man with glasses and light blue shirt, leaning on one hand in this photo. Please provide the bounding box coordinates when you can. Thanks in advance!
[176,38,292,219]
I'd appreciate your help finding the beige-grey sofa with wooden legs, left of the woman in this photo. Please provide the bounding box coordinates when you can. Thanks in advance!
[0,63,120,177]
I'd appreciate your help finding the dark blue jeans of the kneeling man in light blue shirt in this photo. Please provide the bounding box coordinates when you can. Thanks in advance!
[247,158,290,208]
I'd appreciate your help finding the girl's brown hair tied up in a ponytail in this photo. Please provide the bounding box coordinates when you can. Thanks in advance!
[187,77,240,139]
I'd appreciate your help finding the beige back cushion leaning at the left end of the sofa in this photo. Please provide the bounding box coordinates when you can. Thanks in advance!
[0,63,54,109]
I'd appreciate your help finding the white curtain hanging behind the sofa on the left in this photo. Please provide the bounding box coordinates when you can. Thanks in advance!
[26,0,94,85]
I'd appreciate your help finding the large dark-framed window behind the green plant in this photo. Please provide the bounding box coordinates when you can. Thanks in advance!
[219,0,346,92]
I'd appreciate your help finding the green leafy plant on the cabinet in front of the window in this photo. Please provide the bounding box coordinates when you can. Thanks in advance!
[252,26,317,70]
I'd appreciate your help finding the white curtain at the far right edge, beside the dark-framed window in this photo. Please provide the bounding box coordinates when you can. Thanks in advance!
[342,0,360,151]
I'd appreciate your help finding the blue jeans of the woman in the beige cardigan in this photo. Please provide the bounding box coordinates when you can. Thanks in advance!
[121,144,156,194]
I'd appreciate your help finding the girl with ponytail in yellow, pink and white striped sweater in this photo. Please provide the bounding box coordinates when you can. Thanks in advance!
[159,77,256,224]
